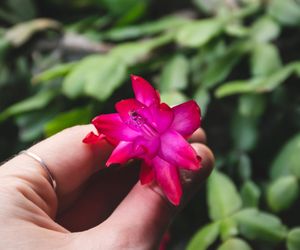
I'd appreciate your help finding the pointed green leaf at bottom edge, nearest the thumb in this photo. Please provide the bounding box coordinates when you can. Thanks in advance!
[187,222,220,250]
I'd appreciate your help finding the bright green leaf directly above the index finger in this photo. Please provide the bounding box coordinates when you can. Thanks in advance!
[44,107,92,136]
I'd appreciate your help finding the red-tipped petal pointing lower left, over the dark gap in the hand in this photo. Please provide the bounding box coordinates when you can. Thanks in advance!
[106,141,144,166]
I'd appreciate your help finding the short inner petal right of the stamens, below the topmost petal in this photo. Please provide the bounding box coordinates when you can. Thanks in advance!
[149,103,174,133]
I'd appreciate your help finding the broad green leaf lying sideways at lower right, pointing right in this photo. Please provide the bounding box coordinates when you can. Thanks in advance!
[234,208,287,244]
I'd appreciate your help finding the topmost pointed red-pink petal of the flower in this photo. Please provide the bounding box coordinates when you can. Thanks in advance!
[131,75,160,106]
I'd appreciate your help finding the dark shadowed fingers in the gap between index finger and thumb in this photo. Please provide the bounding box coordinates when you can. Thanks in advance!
[57,164,139,232]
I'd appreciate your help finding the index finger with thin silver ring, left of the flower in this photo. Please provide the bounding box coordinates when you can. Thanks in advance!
[5,125,112,209]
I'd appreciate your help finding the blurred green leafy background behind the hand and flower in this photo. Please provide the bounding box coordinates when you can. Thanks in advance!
[0,0,300,250]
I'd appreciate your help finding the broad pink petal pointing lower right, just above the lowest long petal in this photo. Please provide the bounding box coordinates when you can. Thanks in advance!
[159,130,200,170]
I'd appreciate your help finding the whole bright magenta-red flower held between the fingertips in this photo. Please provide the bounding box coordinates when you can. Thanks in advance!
[83,75,201,205]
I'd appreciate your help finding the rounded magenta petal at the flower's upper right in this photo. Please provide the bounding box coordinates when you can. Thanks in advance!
[171,101,201,137]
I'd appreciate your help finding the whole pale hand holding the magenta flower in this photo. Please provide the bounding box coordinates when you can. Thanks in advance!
[0,125,214,250]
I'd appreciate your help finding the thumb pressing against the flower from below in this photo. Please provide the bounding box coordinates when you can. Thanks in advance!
[79,144,214,249]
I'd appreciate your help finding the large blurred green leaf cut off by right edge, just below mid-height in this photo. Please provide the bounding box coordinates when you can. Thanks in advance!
[270,134,300,180]
